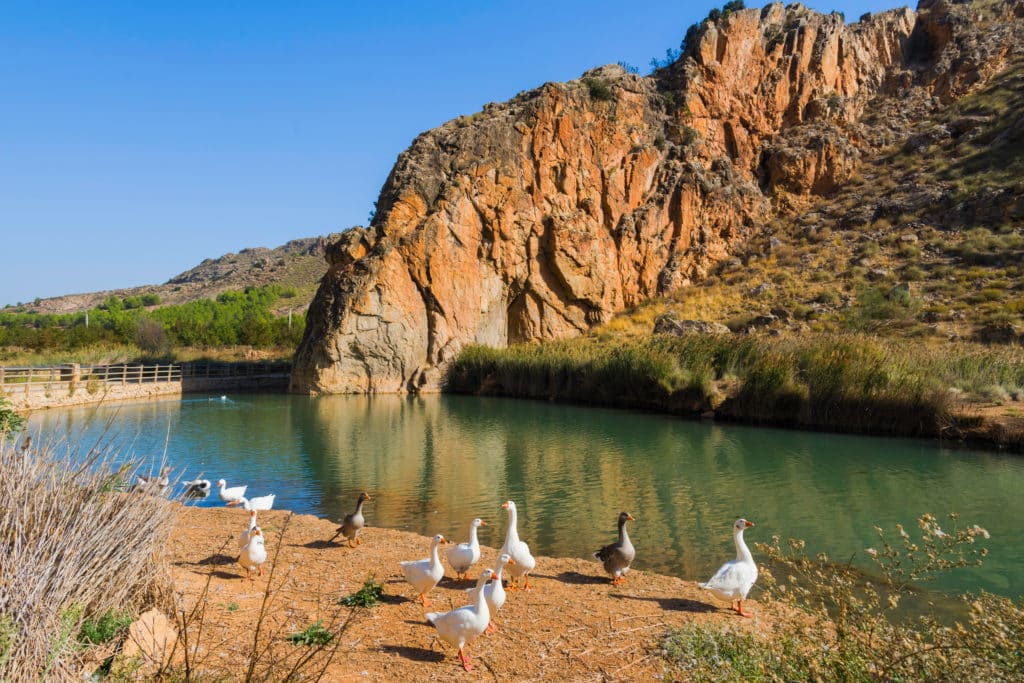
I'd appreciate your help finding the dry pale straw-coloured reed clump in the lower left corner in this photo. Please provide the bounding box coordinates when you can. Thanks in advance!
[0,434,175,682]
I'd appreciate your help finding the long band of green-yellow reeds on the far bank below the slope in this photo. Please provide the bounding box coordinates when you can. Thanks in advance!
[447,335,954,435]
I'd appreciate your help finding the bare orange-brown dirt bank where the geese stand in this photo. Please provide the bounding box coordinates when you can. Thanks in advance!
[168,508,772,681]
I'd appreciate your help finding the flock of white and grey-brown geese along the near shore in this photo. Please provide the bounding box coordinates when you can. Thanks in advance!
[169,468,758,671]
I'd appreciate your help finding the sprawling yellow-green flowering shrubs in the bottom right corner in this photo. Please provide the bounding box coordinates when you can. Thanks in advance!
[662,514,1024,682]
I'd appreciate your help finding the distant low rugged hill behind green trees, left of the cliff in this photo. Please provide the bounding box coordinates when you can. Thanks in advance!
[9,236,338,313]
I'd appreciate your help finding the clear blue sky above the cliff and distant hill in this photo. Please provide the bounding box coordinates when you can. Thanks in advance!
[0,0,895,305]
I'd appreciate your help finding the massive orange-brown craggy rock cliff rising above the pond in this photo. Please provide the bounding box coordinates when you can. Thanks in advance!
[292,0,1024,393]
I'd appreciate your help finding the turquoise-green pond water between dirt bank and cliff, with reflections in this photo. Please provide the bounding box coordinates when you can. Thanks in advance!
[29,394,1024,597]
